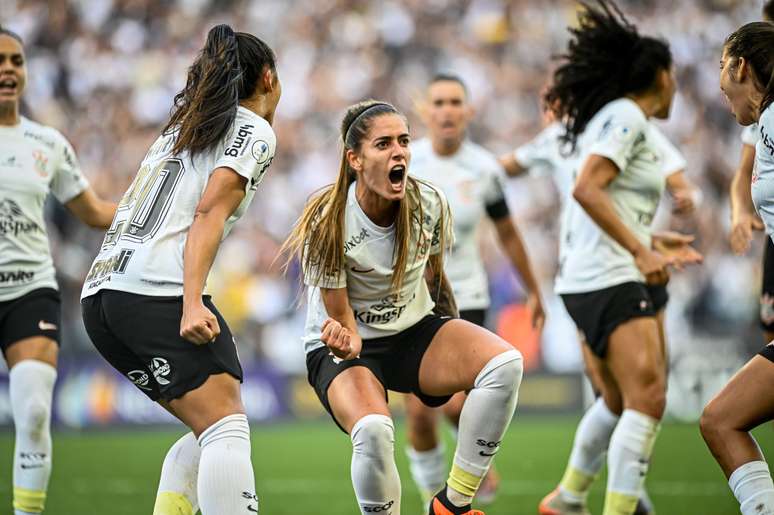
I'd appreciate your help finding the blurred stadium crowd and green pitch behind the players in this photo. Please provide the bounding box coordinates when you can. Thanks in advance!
[0,0,774,515]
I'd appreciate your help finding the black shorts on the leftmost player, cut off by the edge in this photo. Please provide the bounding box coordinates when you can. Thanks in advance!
[0,288,62,354]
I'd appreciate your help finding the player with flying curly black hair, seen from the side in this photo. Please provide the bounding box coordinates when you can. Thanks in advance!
[539,0,700,515]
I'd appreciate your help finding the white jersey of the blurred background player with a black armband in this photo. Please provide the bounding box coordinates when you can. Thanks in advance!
[410,139,508,311]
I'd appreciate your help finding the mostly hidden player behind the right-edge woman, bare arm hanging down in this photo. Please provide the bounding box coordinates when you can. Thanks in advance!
[730,0,774,343]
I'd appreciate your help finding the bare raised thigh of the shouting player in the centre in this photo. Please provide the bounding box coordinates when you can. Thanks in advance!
[419,319,513,396]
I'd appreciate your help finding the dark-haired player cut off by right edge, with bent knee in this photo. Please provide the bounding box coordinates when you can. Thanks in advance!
[701,22,774,515]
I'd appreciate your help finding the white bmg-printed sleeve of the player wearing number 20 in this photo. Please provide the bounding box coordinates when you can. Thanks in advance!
[213,115,277,190]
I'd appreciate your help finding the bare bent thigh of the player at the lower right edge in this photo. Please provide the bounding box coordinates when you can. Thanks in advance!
[705,354,774,431]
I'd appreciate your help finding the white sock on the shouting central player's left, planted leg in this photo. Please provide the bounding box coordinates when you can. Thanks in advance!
[350,414,400,515]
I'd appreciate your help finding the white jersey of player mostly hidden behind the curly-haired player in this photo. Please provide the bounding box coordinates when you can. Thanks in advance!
[513,122,577,204]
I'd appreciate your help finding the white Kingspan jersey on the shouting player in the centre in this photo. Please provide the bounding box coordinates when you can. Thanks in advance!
[303,182,452,353]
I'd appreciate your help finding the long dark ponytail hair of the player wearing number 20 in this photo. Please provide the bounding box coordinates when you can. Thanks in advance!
[163,25,276,154]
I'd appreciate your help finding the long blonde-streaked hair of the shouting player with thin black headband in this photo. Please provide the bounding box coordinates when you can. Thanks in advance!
[281,100,451,293]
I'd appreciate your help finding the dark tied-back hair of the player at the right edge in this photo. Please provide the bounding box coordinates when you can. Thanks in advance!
[724,21,774,113]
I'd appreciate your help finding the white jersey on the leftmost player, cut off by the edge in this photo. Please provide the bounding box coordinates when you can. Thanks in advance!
[0,117,89,302]
